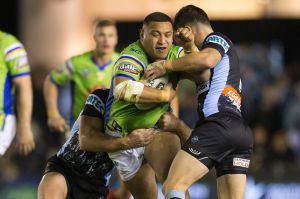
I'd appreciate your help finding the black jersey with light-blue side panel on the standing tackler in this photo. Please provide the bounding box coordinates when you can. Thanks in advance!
[197,32,242,119]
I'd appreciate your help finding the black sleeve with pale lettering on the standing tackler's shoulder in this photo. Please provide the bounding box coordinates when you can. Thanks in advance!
[202,32,232,57]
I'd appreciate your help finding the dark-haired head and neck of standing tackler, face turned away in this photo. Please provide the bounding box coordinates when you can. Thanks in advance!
[174,5,211,45]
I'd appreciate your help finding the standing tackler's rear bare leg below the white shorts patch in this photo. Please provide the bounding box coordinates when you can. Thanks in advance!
[217,174,246,199]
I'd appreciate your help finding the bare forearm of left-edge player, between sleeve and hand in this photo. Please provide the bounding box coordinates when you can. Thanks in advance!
[16,76,33,128]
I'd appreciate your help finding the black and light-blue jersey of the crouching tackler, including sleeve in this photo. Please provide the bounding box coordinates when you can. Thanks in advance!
[57,89,113,184]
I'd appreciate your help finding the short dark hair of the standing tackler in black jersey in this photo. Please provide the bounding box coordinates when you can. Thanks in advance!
[174,5,210,29]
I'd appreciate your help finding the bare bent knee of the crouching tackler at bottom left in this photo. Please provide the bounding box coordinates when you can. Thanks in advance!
[38,172,68,199]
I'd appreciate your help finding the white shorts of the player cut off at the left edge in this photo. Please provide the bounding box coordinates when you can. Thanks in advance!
[0,114,16,155]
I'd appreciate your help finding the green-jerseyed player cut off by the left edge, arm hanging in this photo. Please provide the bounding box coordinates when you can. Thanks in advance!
[0,31,35,156]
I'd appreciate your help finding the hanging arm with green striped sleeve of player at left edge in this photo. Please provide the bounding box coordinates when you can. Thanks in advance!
[3,35,35,155]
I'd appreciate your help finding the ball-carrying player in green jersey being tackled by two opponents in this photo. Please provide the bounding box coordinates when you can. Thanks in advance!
[105,12,190,199]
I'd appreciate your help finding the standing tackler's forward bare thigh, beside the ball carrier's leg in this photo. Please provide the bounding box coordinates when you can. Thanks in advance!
[163,150,209,194]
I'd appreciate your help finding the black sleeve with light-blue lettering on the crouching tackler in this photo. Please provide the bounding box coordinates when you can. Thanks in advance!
[81,89,109,120]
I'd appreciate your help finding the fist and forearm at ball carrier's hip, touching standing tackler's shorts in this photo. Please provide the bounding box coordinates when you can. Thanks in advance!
[159,113,192,145]
